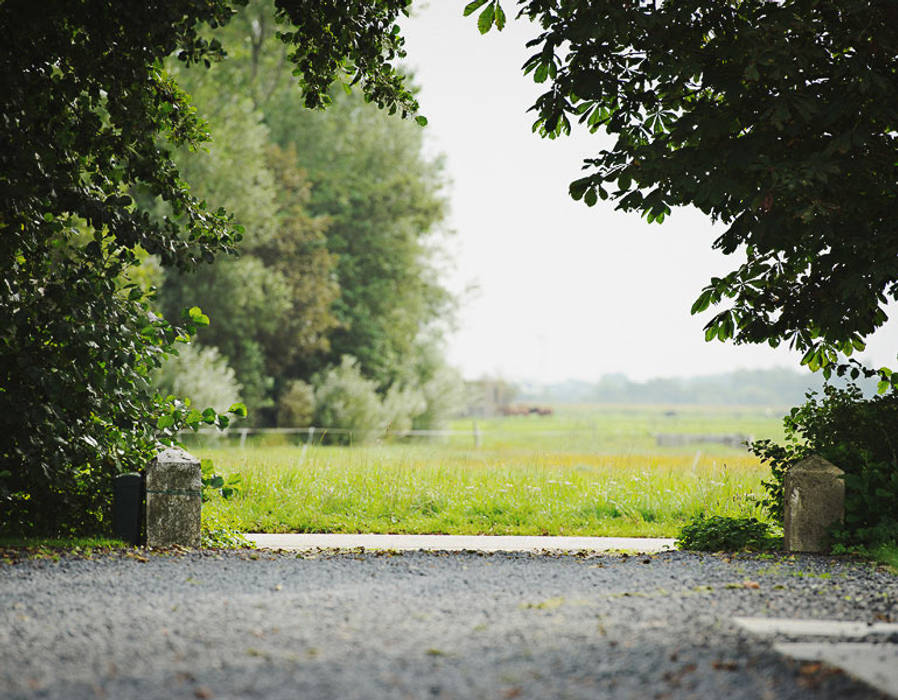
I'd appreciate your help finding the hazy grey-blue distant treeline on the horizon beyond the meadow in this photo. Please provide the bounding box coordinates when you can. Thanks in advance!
[518,369,876,407]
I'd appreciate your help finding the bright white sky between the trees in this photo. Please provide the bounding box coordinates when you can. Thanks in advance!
[402,0,898,382]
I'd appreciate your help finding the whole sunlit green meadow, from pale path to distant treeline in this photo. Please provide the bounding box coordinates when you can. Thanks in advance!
[189,406,782,537]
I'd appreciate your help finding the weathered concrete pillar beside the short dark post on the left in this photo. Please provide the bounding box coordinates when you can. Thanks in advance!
[146,447,203,547]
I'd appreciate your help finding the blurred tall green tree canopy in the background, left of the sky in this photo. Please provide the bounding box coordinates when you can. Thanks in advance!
[160,0,450,424]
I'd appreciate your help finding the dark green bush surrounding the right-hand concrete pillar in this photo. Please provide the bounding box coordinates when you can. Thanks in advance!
[752,386,898,546]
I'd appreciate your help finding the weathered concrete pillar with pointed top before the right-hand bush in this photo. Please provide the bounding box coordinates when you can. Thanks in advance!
[783,455,845,552]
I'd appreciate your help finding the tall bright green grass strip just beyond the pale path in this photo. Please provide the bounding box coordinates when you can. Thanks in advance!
[197,441,767,536]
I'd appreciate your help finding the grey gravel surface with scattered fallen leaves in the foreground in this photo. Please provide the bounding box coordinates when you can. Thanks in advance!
[0,551,898,700]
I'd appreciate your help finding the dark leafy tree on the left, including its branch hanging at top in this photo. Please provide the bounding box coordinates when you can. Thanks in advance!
[0,0,417,532]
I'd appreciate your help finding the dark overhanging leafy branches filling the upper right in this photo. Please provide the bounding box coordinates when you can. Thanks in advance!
[465,0,898,372]
